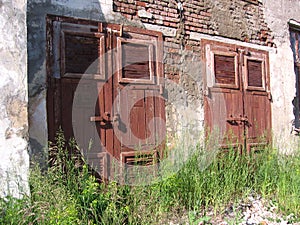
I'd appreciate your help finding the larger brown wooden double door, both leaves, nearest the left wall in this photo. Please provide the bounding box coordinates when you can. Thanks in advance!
[47,17,165,183]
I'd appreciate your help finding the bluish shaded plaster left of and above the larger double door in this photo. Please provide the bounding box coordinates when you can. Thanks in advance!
[27,0,105,162]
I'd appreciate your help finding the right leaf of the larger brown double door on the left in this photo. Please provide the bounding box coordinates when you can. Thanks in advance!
[100,26,165,182]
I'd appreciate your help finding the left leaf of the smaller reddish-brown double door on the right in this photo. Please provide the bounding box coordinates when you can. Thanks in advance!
[203,42,244,150]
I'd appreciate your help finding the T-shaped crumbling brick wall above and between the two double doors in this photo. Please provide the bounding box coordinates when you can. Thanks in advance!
[113,0,274,139]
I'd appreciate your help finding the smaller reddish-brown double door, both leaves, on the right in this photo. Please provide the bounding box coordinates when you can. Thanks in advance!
[202,41,271,151]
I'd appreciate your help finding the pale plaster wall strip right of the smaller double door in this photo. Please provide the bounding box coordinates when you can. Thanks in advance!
[264,0,300,152]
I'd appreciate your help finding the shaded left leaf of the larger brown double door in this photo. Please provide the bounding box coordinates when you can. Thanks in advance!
[47,16,111,176]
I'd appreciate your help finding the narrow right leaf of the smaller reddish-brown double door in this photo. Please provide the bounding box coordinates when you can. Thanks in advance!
[243,49,271,151]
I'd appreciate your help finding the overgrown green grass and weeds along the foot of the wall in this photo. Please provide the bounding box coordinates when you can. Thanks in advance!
[0,131,300,225]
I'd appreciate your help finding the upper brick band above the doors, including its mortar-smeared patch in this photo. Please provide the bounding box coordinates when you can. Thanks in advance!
[113,0,273,46]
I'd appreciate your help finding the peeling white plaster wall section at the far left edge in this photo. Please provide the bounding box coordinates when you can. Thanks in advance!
[0,0,29,197]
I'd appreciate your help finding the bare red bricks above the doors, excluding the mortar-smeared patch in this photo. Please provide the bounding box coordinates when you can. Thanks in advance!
[113,0,273,47]
